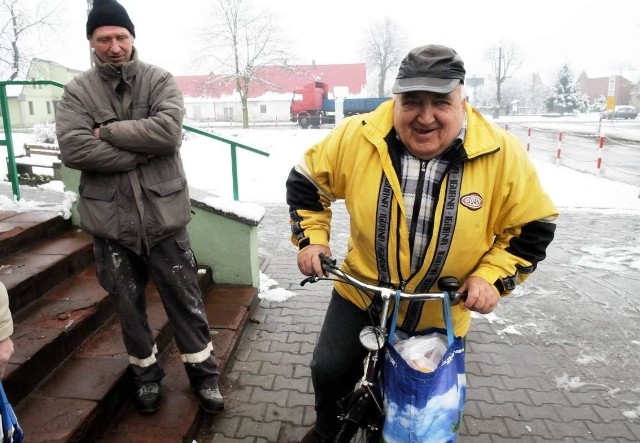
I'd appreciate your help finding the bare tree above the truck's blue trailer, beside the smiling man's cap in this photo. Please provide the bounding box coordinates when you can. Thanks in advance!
[365,18,407,97]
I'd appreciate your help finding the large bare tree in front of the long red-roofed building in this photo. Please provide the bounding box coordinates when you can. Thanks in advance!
[204,0,288,128]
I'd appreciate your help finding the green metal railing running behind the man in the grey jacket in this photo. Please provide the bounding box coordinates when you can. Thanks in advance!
[0,80,269,201]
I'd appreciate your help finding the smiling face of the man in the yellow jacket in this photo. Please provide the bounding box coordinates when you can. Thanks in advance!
[393,85,465,160]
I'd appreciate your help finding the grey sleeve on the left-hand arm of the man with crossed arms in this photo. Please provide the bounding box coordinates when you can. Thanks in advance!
[56,80,143,173]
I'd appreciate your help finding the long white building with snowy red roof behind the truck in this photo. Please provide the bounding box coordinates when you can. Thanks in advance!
[175,63,367,123]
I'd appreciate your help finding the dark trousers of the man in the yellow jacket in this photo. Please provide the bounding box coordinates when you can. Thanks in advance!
[311,290,371,439]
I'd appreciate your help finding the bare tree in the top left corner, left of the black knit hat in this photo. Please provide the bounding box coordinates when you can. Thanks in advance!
[0,0,57,80]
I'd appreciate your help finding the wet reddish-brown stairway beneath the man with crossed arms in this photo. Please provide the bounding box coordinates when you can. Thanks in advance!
[0,211,257,443]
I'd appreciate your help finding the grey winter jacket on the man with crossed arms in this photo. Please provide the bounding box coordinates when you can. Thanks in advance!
[56,48,191,253]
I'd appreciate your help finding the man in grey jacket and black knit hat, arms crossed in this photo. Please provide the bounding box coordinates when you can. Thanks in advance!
[56,0,224,413]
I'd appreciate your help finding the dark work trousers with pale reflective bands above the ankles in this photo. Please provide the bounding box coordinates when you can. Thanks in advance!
[94,229,219,389]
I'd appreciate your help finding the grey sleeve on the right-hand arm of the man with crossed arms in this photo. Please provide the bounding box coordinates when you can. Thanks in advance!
[100,70,184,155]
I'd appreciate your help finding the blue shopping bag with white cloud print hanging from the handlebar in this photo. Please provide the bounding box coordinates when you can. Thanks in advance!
[382,294,467,443]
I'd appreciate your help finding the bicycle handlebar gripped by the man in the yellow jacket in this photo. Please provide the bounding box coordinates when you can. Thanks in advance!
[300,254,467,305]
